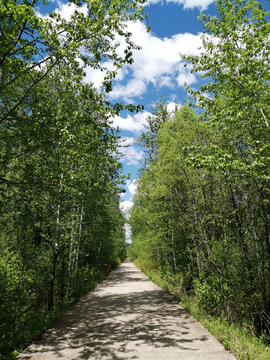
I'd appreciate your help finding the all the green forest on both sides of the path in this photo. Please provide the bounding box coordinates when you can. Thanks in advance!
[0,0,270,359]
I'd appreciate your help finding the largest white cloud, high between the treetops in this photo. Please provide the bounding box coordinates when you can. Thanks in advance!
[108,21,202,102]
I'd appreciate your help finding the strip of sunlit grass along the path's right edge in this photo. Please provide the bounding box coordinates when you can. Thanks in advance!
[133,259,270,360]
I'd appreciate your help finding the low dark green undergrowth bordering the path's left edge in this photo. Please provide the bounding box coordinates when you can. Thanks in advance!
[0,251,108,359]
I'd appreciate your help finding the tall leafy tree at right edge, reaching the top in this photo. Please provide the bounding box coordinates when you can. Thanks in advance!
[183,0,270,331]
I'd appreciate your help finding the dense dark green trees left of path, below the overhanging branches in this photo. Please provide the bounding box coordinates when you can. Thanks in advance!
[0,64,125,353]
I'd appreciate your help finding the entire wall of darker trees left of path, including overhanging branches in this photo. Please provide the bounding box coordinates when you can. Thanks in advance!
[0,0,148,358]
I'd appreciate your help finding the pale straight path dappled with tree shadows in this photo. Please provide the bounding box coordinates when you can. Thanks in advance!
[17,260,235,360]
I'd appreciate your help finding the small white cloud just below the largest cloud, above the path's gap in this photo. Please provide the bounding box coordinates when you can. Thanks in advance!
[112,110,151,134]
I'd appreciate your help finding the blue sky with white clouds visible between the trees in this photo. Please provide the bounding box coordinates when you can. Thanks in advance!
[37,0,269,242]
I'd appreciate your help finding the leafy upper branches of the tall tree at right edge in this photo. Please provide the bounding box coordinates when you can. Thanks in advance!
[183,0,270,179]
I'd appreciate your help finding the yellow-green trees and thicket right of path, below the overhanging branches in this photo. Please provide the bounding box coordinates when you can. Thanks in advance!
[129,94,270,348]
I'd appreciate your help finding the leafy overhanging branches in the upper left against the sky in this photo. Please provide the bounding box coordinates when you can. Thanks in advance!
[0,0,148,123]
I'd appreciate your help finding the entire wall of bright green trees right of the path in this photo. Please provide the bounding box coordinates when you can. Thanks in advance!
[129,0,270,346]
